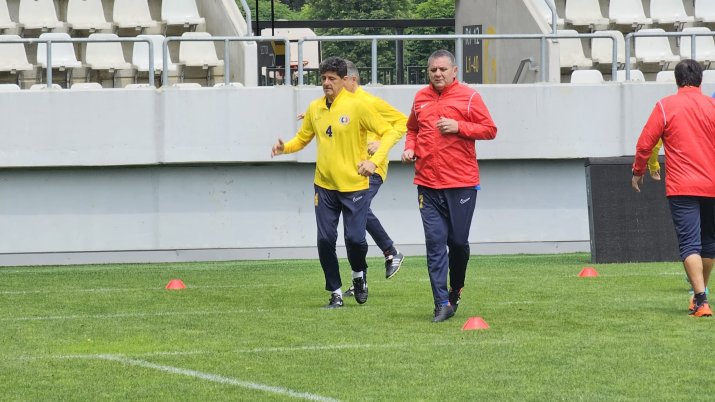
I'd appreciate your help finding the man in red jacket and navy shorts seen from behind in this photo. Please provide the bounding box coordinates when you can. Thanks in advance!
[631,59,715,317]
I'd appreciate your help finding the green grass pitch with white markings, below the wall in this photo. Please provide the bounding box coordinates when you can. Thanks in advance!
[0,254,715,401]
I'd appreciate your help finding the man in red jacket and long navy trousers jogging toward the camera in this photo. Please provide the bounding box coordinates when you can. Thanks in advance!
[402,50,497,322]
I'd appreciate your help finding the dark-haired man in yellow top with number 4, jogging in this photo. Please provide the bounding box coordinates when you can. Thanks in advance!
[271,57,400,308]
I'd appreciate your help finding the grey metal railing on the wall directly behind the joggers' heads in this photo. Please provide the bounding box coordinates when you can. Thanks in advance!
[298,32,618,85]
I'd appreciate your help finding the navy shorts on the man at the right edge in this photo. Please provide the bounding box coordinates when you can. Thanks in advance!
[668,195,715,260]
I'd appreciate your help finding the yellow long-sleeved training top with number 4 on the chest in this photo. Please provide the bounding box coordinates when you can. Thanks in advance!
[283,89,400,192]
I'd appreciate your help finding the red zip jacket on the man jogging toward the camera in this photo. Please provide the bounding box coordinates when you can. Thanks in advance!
[405,81,497,189]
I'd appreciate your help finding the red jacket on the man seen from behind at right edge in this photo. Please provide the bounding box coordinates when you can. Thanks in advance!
[633,87,715,197]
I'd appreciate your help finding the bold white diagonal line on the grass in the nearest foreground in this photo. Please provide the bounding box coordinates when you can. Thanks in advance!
[85,355,337,402]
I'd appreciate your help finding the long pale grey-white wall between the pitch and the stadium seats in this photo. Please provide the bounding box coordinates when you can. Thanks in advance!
[0,83,713,264]
